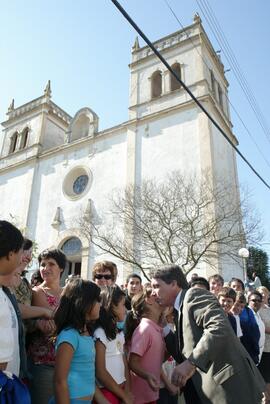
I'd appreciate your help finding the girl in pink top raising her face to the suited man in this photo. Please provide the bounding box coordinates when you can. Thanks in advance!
[126,288,165,404]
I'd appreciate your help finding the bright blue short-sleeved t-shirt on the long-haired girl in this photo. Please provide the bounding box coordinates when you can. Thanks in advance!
[56,328,96,398]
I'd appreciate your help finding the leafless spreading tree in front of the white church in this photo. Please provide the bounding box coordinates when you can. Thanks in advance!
[79,171,261,276]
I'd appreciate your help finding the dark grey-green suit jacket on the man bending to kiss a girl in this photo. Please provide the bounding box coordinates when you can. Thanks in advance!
[165,288,265,404]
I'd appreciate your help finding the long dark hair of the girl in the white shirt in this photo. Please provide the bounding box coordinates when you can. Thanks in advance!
[95,285,126,340]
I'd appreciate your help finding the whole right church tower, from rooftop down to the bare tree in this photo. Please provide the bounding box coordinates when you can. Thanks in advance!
[127,14,241,279]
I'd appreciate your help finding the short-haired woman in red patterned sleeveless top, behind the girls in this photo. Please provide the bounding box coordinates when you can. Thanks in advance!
[28,249,66,404]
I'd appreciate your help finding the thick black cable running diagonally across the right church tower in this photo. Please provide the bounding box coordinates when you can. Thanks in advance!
[111,0,270,190]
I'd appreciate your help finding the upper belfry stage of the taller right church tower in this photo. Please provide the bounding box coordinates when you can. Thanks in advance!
[129,14,231,127]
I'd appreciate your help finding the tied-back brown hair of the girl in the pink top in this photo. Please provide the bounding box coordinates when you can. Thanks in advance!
[125,288,152,342]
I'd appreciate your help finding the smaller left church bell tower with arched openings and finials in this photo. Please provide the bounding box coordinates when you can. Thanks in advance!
[0,80,71,163]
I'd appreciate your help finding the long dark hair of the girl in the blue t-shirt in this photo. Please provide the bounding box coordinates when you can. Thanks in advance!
[54,278,100,335]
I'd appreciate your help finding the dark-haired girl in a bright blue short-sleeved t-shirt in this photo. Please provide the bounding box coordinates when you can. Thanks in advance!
[50,279,106,404]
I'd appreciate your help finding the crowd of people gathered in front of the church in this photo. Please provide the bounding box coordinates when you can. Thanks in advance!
[0,221,270,404]
